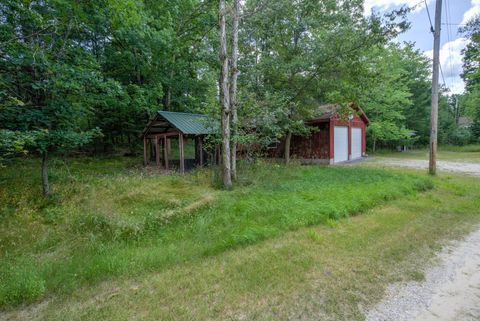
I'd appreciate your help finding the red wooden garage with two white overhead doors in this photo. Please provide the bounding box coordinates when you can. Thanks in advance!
[270,104,370,164]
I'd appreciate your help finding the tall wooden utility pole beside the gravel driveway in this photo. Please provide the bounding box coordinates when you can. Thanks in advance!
[429,0,442,175]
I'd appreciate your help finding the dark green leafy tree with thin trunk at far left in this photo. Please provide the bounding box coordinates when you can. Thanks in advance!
[0,0,103,196]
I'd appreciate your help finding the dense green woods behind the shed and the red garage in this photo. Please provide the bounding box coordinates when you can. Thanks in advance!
[0,0,472,192]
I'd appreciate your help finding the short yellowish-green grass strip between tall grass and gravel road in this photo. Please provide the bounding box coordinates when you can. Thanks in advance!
[3,172,480,321]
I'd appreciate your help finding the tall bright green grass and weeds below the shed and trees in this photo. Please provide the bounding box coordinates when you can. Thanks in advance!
[0,159,432,307]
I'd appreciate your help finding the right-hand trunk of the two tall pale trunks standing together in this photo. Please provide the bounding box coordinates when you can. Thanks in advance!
[230,0,240,180]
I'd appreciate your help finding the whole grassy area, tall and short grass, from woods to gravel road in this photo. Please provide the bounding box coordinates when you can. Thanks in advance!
[0,154,480,320]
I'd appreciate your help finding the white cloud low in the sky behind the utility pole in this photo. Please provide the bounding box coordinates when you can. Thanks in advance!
[425,38,468,94]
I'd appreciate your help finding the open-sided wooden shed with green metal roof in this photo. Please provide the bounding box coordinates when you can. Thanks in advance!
[142,111,216,173]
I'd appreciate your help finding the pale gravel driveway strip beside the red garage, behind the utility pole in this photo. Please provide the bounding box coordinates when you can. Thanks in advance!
[377,158,480,177]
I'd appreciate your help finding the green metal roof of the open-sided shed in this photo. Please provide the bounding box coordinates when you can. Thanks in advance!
[158,110,213,135]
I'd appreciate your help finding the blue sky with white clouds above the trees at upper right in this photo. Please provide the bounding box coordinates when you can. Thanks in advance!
[365,0,480,94]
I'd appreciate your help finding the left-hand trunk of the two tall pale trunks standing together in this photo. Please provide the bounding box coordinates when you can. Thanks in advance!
[219,0,232,189]
